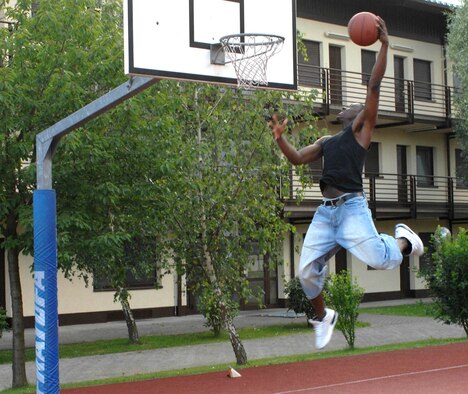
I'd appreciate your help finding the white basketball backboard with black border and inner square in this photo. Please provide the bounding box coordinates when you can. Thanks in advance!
[124,0,297,90]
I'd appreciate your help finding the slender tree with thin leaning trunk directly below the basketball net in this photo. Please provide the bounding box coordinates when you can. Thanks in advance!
[150,83,313,364]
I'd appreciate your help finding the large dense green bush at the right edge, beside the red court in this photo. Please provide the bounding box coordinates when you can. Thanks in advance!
[418,227,468,336]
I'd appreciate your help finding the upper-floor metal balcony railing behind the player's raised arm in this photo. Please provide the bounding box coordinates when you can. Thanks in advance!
[298,64,454,122]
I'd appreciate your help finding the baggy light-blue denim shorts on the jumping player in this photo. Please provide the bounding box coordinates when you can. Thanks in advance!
[299,196,403,299]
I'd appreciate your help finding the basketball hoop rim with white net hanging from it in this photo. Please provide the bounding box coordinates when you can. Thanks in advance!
[219,33,284,89]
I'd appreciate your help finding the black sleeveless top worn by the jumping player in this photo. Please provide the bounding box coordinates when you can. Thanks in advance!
[320,125,367,193]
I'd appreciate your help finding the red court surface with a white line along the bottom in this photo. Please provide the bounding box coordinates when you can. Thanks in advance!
[63,342,468,394]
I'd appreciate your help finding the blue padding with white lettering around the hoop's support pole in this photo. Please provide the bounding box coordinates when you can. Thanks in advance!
[33,190,60,394]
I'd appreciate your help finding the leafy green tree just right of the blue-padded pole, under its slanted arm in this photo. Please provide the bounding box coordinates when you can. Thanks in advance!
[50,94,176,343]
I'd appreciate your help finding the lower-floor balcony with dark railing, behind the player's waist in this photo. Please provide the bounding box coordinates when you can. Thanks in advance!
[281,169,468,222]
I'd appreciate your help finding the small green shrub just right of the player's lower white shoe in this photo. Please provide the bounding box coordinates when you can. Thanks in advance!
[323,270,364,349]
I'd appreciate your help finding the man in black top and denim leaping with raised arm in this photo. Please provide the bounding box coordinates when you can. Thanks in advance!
[268,17,424,349]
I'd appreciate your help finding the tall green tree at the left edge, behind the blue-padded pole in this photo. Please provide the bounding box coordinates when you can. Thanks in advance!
[0,0,123,387]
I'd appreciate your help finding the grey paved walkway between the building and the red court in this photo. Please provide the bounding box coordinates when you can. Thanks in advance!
[0,299,465,390]
